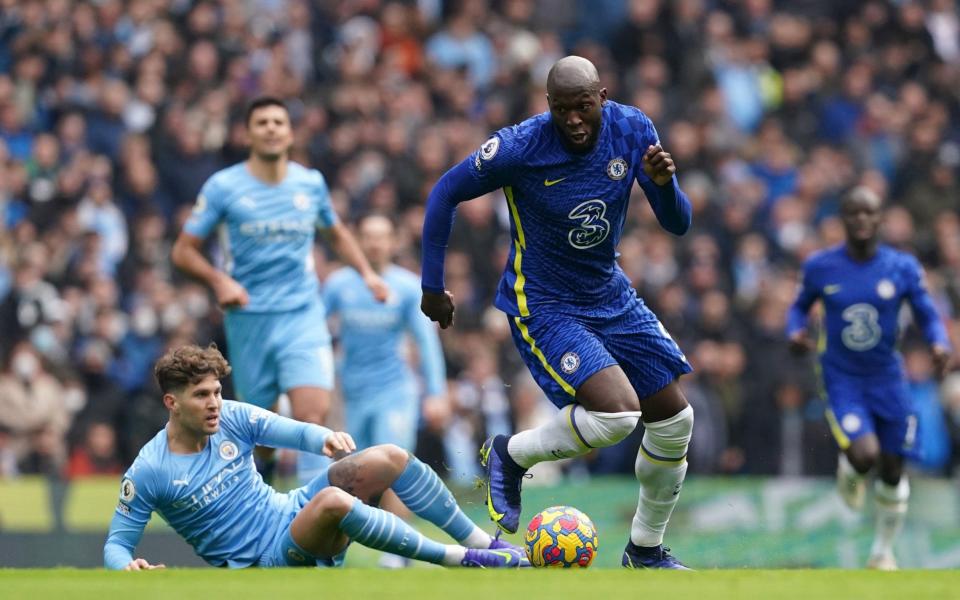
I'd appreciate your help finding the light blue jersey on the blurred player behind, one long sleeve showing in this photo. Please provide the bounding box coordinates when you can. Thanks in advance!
[323,265,446,397]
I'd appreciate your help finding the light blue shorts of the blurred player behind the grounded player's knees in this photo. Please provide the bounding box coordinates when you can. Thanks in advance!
[343,381,420,452]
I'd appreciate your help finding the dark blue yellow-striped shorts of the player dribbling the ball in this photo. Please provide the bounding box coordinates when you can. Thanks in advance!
[508,296,693,408]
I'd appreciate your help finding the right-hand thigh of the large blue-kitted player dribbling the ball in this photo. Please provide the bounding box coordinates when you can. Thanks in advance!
[600,299,693,406]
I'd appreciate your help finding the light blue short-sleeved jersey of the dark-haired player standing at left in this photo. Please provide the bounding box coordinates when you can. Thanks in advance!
[184,162,337,312]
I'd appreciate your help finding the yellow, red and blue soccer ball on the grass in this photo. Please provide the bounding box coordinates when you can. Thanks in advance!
[523,506,600,568]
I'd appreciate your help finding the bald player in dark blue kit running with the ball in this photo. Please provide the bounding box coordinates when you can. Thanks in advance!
[421,56,693,569]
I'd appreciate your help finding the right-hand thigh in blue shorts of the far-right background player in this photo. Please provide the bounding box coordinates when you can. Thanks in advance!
[865,374,917,457]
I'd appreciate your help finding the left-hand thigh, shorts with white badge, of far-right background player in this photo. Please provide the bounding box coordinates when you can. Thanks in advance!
[821,367,876,450]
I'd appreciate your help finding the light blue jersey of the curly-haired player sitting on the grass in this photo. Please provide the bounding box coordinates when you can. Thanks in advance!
[104,400,330,569]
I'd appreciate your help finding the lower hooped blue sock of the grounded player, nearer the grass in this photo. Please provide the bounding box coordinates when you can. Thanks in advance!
[340,500,447,564]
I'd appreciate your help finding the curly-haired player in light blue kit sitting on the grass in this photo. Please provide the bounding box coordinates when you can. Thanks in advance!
[103,346,529,571]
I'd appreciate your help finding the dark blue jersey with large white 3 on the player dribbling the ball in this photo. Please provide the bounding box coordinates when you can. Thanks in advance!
[471,100,658,316]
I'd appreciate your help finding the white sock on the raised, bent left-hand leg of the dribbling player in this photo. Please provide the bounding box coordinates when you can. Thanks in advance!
[507,404,640,469]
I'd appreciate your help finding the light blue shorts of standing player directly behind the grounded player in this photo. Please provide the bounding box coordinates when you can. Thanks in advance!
[224,301,333,409]
